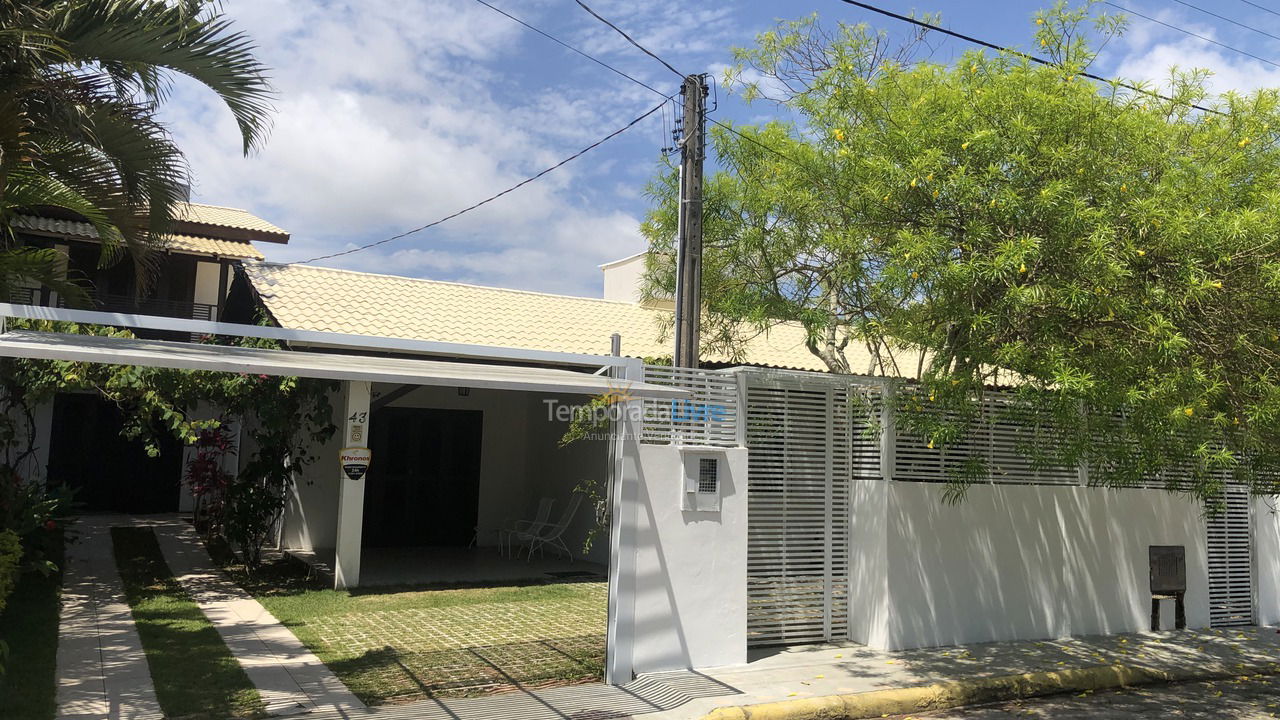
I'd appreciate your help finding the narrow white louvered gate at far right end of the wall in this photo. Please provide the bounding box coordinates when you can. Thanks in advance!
[1206,486,1253,628]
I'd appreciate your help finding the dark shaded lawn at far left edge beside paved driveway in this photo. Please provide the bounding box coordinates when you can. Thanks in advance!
[0,530,63,720]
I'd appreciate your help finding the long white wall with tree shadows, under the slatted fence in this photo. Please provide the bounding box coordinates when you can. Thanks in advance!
[851,482,1208,650]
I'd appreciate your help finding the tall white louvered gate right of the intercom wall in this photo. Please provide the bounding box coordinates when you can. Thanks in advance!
[745,374,878,647]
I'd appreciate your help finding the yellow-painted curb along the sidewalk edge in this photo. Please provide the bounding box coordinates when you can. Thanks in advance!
[703,664,1277,720]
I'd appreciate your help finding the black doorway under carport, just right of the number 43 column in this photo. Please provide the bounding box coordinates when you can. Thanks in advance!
[364,407,484,547]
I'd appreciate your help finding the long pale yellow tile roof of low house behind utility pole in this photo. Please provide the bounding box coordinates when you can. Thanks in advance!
[244,263,852,370]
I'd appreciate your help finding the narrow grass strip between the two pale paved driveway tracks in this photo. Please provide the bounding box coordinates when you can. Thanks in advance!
[111,528,262,720]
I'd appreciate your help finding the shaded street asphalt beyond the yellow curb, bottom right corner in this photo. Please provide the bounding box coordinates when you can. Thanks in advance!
[901,675,1280,720]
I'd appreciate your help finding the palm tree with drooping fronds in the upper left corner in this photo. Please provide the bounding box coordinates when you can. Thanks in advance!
[0,0,271,301]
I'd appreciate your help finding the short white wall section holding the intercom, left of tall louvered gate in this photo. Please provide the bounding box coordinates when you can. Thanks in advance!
[609,437,746,682]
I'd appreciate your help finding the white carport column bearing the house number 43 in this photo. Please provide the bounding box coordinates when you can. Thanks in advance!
[330,380,370,589]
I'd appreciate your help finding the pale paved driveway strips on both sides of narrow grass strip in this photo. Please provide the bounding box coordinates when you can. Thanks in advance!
[58,515,365,720]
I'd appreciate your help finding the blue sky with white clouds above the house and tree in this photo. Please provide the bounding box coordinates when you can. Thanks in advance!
[164,0,1280,296]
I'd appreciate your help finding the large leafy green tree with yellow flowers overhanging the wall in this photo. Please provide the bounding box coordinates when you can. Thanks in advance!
[644,4,1280,500]
